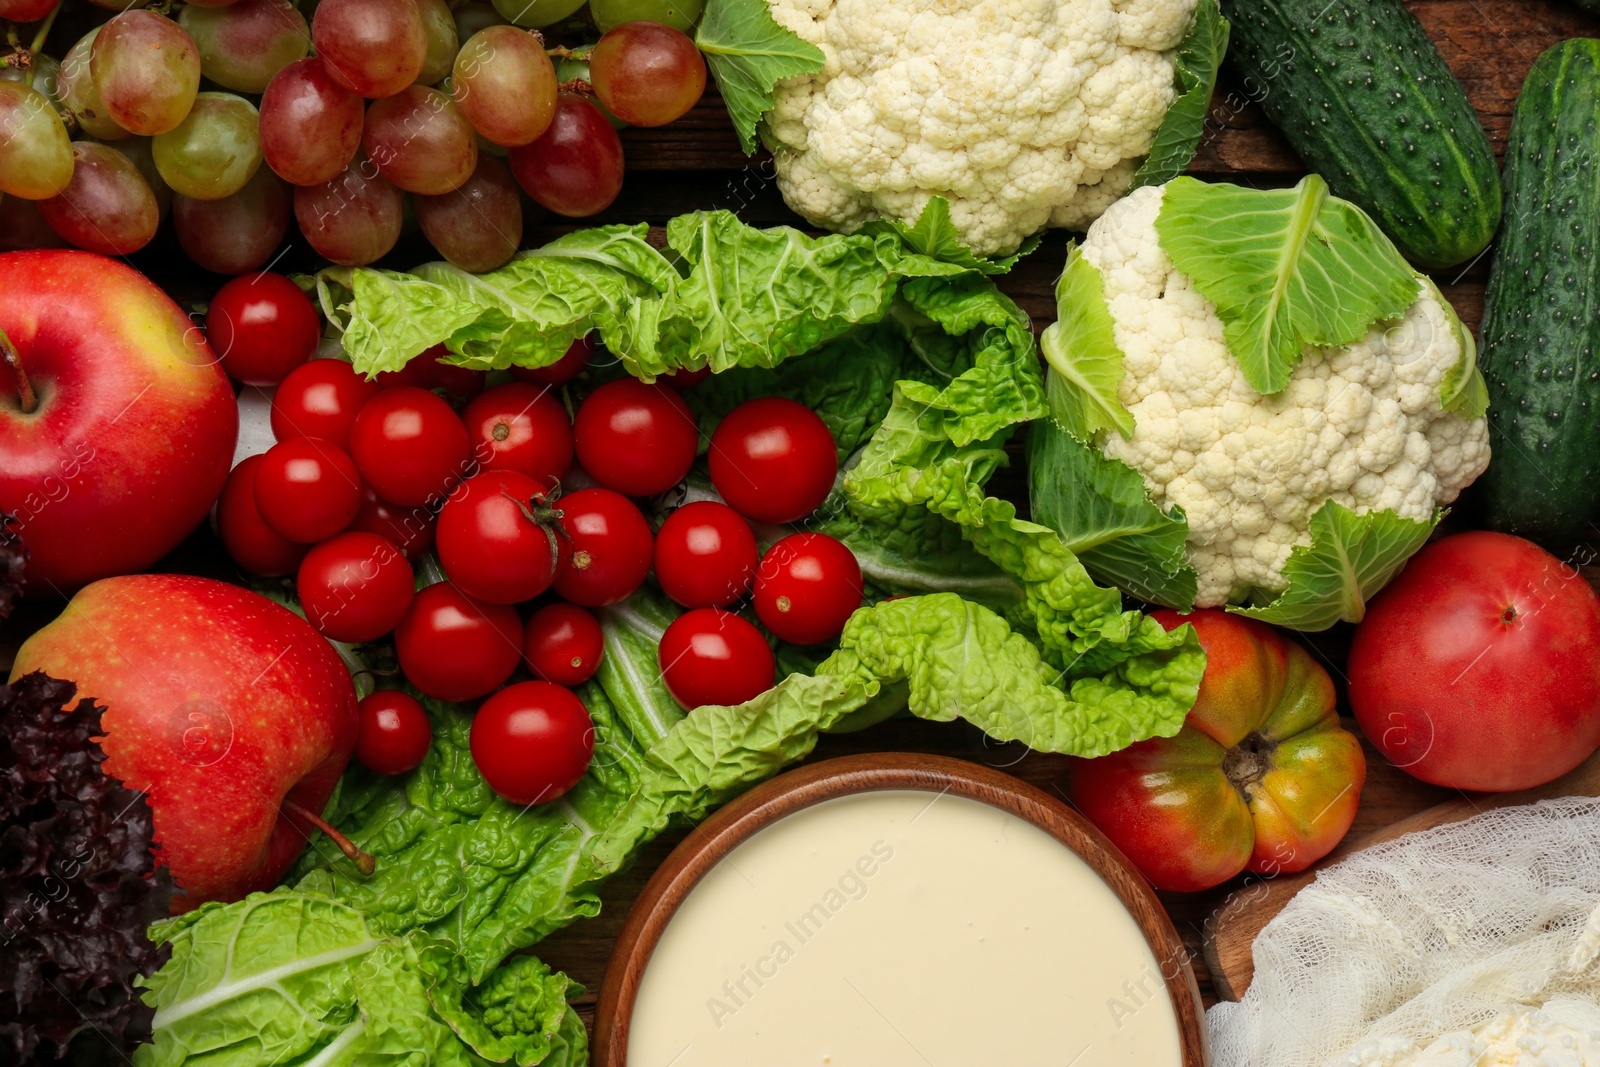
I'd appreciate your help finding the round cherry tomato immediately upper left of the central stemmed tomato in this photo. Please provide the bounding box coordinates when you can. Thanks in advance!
[350,386,472,504]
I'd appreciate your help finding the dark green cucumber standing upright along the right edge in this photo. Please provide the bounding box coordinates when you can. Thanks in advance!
[1474,38,1600,549]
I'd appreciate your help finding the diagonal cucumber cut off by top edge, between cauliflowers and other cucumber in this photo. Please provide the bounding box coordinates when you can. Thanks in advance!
[1222,0,1501,269]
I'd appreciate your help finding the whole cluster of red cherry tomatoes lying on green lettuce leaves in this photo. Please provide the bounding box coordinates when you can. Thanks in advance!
[206,274,862,803]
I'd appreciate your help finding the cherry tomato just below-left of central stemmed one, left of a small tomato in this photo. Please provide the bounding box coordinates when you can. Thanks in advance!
[395,582,522,701]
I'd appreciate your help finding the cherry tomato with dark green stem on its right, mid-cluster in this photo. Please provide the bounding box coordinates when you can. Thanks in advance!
[435,470,568,603]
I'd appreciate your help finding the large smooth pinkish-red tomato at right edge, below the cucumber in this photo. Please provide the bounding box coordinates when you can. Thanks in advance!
[1350,531,1600,790]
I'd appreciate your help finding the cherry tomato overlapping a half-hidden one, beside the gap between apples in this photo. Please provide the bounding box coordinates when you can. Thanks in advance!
[254,437,362,542]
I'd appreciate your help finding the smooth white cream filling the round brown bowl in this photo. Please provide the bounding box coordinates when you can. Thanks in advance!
[627,790,1182,1067]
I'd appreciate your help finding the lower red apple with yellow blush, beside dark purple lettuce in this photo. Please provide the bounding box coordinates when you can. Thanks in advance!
[11,574,358,909]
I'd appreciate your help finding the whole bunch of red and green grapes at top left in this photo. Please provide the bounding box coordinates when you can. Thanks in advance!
[0,0,706,274]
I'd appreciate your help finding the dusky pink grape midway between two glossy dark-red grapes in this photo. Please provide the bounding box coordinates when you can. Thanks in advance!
[362,85,478,195]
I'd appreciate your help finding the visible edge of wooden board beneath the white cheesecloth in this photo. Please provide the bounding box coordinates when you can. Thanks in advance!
[1203,752,1600,1000]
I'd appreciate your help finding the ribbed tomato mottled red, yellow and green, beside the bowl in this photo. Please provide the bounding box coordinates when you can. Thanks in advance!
[1072,611,1366,891]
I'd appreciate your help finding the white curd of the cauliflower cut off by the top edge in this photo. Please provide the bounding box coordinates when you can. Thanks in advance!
[766,0,1195,254]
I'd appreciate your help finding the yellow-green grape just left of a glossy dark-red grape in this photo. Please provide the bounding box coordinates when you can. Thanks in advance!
[150,93,261,200]
